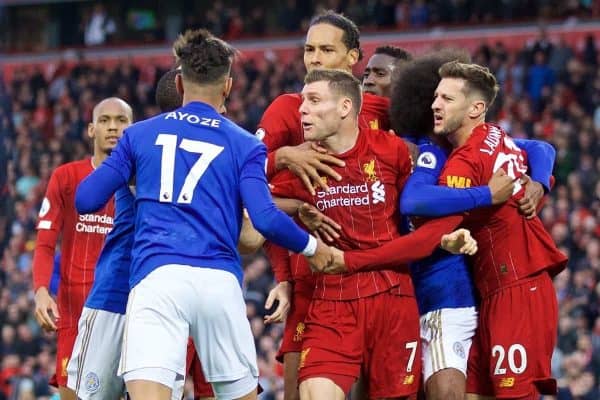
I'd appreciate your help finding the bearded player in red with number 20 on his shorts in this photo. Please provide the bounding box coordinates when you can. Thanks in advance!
[329,62,567,399]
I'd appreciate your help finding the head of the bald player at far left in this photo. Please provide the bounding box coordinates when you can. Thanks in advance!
[88,99,132,154]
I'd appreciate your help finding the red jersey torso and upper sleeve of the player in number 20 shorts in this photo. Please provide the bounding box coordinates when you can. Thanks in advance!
[439,124,567,296]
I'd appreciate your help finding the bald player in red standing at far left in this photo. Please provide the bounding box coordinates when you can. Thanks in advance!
[33,97,133,399]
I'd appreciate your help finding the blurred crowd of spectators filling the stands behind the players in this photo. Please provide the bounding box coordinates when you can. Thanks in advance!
[0,0,600,400]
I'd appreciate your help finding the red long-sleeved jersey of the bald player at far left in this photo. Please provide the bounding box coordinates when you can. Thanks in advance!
[33,158,115,327]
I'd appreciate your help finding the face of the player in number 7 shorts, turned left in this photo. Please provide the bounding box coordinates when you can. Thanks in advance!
[300,81,342,142]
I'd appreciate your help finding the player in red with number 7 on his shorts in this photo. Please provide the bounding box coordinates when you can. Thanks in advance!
[272,69,478,399]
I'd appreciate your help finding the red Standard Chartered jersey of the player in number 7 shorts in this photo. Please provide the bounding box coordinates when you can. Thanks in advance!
[272,128,413,300]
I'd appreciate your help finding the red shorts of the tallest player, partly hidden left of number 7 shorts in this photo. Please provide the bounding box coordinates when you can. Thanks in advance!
[276,285,314,362]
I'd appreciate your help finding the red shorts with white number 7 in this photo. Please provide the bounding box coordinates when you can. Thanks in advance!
[298,291,421,398]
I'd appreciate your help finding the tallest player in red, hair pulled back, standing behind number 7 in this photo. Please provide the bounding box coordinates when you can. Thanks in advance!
[256,11,389,400]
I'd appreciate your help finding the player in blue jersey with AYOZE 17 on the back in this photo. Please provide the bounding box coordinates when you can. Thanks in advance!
[76,30,331,400]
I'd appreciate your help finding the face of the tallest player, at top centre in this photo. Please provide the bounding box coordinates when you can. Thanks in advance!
[304,24,356,72]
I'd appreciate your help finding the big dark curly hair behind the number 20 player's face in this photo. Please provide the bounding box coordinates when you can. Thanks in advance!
[390,49,470,137]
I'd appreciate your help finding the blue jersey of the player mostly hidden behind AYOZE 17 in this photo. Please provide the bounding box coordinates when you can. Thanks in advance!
[85,185,135,314]
